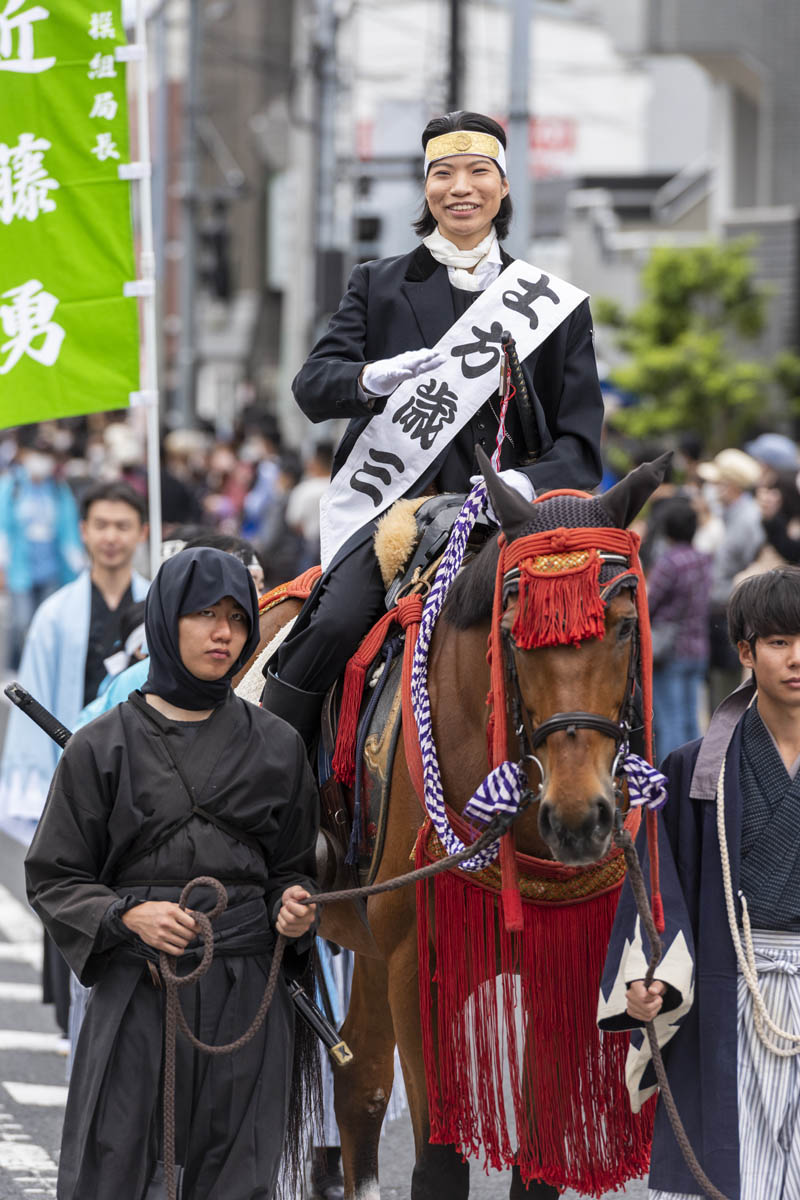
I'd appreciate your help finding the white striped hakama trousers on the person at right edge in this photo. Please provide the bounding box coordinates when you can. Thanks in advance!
[649,929,800,1200]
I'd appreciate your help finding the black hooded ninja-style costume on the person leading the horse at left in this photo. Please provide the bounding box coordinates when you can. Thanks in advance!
[25,548,318,1200]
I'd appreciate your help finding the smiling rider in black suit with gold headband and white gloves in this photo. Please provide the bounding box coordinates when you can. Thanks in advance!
[263,112,603,742]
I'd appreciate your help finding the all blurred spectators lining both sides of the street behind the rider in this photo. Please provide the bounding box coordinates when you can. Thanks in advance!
[0,412,800,756]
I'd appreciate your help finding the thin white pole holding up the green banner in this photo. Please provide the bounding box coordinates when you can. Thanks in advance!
[136,0,161,576]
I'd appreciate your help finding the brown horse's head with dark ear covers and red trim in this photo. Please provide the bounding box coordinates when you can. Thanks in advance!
[481,454,672,865]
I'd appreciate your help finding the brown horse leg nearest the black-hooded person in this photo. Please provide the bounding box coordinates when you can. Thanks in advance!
[333,954,395,1200]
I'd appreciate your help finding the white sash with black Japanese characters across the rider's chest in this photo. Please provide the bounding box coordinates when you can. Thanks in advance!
[319,259,587,569]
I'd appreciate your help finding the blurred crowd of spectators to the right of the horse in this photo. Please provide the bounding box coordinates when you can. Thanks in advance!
[640,432,800,758]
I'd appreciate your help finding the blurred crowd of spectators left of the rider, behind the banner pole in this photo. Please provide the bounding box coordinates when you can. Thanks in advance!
[0,413,332,671]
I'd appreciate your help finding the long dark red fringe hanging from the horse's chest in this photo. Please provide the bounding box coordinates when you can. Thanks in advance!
[416,839,654,1196]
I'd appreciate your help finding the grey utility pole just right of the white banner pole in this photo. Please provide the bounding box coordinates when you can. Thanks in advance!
[176,0,203,428]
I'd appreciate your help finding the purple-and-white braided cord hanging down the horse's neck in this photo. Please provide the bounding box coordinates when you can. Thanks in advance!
[411,481,528,871]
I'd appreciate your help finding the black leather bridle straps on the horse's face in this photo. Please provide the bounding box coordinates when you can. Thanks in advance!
[503,550,639,800]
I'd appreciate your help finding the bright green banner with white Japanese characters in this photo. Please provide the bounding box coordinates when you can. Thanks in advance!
[0,0,139,428]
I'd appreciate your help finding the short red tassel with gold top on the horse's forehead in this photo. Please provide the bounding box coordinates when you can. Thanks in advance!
[511,550,606,650]
